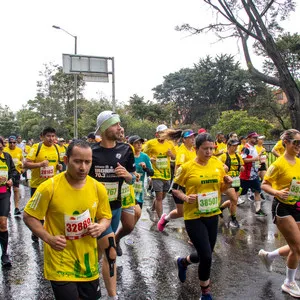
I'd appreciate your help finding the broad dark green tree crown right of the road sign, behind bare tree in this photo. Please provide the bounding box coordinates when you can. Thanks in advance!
[153,54,262,128]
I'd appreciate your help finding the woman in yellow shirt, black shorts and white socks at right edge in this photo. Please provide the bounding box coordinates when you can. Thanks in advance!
[259,129,300,298]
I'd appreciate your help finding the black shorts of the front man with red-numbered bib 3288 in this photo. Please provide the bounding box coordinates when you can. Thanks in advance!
[51,278,101,300]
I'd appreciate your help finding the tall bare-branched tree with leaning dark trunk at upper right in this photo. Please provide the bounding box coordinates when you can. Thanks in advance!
[176,0,300,130]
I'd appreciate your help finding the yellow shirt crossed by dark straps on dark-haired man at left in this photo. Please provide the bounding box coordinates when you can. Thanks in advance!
[26,143,59,188]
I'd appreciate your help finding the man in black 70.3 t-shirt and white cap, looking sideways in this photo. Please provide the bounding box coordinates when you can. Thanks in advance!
[89,111,135,299]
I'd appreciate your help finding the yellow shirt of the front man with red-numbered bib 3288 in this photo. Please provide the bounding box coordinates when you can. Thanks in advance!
[24,172,112,281]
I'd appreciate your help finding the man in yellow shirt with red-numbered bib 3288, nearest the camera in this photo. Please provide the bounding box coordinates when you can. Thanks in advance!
[24,140,112,300]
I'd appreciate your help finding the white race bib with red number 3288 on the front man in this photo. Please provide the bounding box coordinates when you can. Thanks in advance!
[64,209,92,240]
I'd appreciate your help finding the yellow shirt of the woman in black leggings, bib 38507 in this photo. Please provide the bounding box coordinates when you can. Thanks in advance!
[174,157,226,220]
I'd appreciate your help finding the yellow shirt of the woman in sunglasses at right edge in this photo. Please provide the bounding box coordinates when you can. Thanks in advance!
[264,156,300,205]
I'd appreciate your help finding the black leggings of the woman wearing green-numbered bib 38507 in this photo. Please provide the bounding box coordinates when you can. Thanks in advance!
[184,216,218,281]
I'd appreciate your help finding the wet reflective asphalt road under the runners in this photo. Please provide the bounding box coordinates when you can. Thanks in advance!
[0,183,300,300]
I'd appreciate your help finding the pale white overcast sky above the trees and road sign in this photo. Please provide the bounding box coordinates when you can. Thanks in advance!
[0,0,300,111]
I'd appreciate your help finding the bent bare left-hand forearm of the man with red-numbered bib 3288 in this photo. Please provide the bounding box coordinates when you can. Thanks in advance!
[23,212,67,251]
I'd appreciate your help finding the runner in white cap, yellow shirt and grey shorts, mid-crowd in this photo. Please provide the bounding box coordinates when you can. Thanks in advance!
[144,124,176,221]
